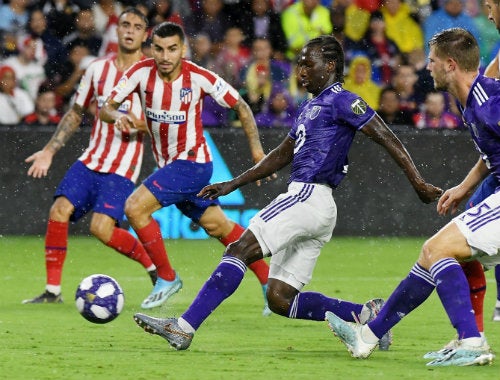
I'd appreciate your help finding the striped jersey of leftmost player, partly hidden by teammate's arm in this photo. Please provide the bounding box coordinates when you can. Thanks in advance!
[75,54,144,182]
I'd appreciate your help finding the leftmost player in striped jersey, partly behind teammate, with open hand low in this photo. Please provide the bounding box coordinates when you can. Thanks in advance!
[23,8,156,303]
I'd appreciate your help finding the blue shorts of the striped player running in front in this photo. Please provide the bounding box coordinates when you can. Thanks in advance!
[143,160,219,223]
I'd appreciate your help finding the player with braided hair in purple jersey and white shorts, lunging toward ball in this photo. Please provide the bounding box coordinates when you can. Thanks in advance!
[134,36,442,350]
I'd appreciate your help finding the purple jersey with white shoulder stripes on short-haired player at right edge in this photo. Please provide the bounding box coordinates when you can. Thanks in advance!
[460,75,500,186]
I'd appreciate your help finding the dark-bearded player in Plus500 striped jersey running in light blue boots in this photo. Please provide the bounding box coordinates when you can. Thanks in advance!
[100,22,270,315]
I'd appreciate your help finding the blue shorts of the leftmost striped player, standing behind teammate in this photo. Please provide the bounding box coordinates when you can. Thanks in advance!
[54,161,134,222]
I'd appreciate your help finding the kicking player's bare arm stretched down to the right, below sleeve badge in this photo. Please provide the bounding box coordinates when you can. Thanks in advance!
[361,114,443,203]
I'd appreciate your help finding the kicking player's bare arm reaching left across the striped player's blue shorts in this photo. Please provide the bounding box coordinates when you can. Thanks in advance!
[198,136,295,199]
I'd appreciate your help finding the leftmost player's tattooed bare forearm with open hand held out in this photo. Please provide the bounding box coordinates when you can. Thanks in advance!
[25,104,84,178]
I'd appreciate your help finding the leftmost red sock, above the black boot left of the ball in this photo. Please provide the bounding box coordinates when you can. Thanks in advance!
[45,219,68,286]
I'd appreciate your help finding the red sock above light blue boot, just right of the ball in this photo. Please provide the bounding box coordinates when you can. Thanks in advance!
[136,219,175,281]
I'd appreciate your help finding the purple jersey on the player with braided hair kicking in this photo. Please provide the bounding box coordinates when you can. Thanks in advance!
[289,83,375,188]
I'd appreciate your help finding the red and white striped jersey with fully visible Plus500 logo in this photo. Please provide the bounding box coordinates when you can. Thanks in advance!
[111,58,239,168]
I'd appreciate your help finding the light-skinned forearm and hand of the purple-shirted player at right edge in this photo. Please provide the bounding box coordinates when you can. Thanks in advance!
[436,158,489,215]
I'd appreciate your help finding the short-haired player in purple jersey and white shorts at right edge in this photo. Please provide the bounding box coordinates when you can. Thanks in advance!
[325,28,500,367]
